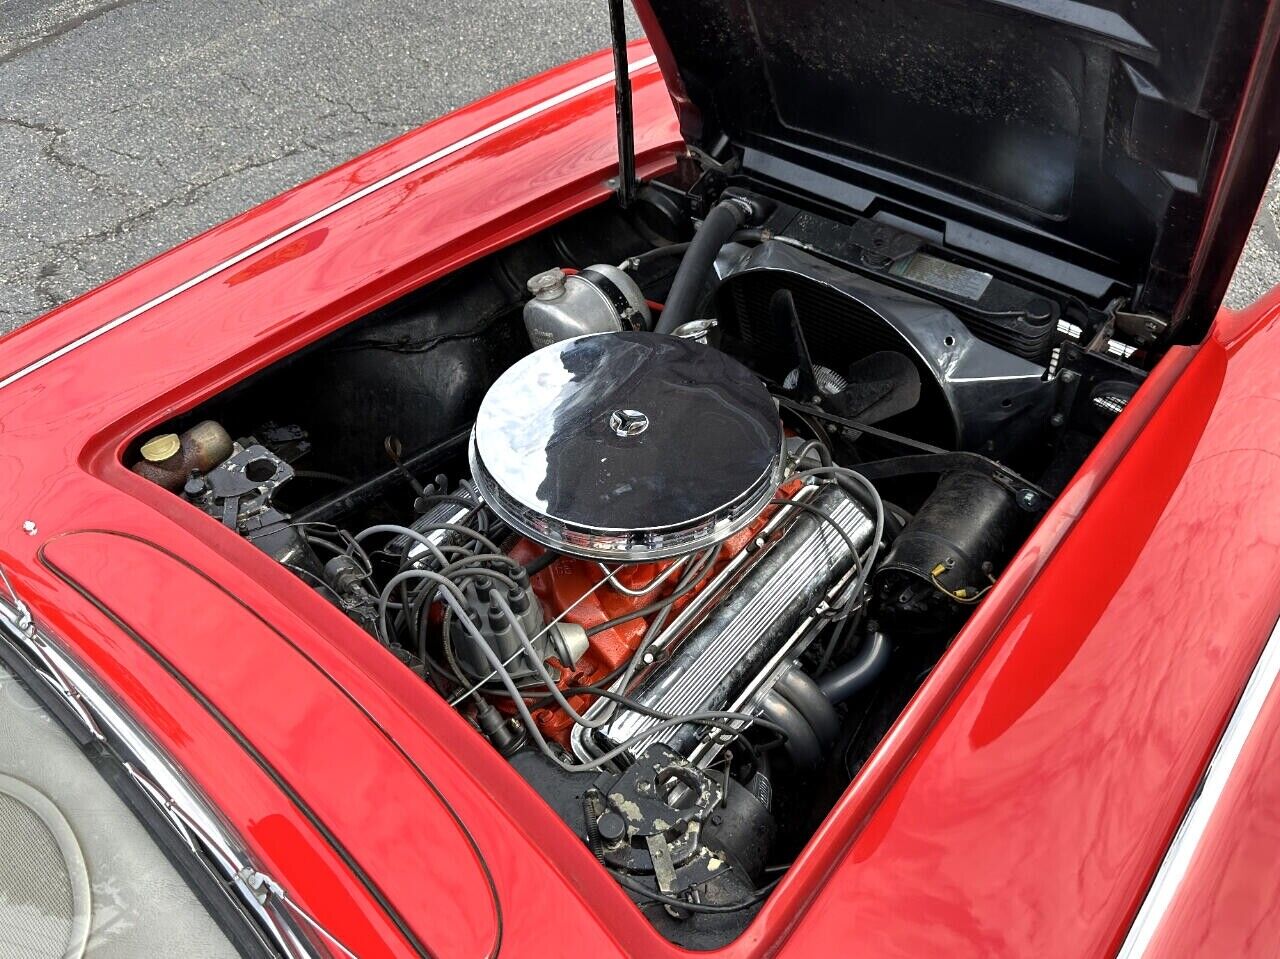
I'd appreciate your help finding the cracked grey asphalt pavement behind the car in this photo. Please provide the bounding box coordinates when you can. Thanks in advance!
[0,0,1280,332]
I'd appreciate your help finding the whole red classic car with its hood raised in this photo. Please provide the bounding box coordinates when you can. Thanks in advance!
[0,0,1280,958]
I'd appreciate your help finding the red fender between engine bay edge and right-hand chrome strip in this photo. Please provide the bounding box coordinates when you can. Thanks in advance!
[773,288,1280,956]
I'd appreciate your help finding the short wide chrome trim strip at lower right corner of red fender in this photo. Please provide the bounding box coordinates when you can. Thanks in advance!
[1116,622,1280,959]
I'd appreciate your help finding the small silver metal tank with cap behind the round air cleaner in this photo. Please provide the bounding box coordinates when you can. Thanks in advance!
[525,264,653,350]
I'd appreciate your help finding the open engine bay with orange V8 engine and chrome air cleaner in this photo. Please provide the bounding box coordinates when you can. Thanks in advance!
[128,170,1146,949]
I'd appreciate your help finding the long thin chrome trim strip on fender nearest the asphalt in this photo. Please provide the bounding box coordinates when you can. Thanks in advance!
[0,55,658,389]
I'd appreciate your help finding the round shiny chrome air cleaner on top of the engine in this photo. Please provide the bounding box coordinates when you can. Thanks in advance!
[471,333,782,561]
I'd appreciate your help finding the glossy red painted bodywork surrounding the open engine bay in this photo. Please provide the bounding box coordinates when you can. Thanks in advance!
[0,45,1280,956]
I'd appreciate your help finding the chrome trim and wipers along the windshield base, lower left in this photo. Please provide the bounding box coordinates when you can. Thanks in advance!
[0,598,325,959]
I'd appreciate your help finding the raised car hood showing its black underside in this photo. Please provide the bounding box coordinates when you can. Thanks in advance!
[636,0,1280,341]
